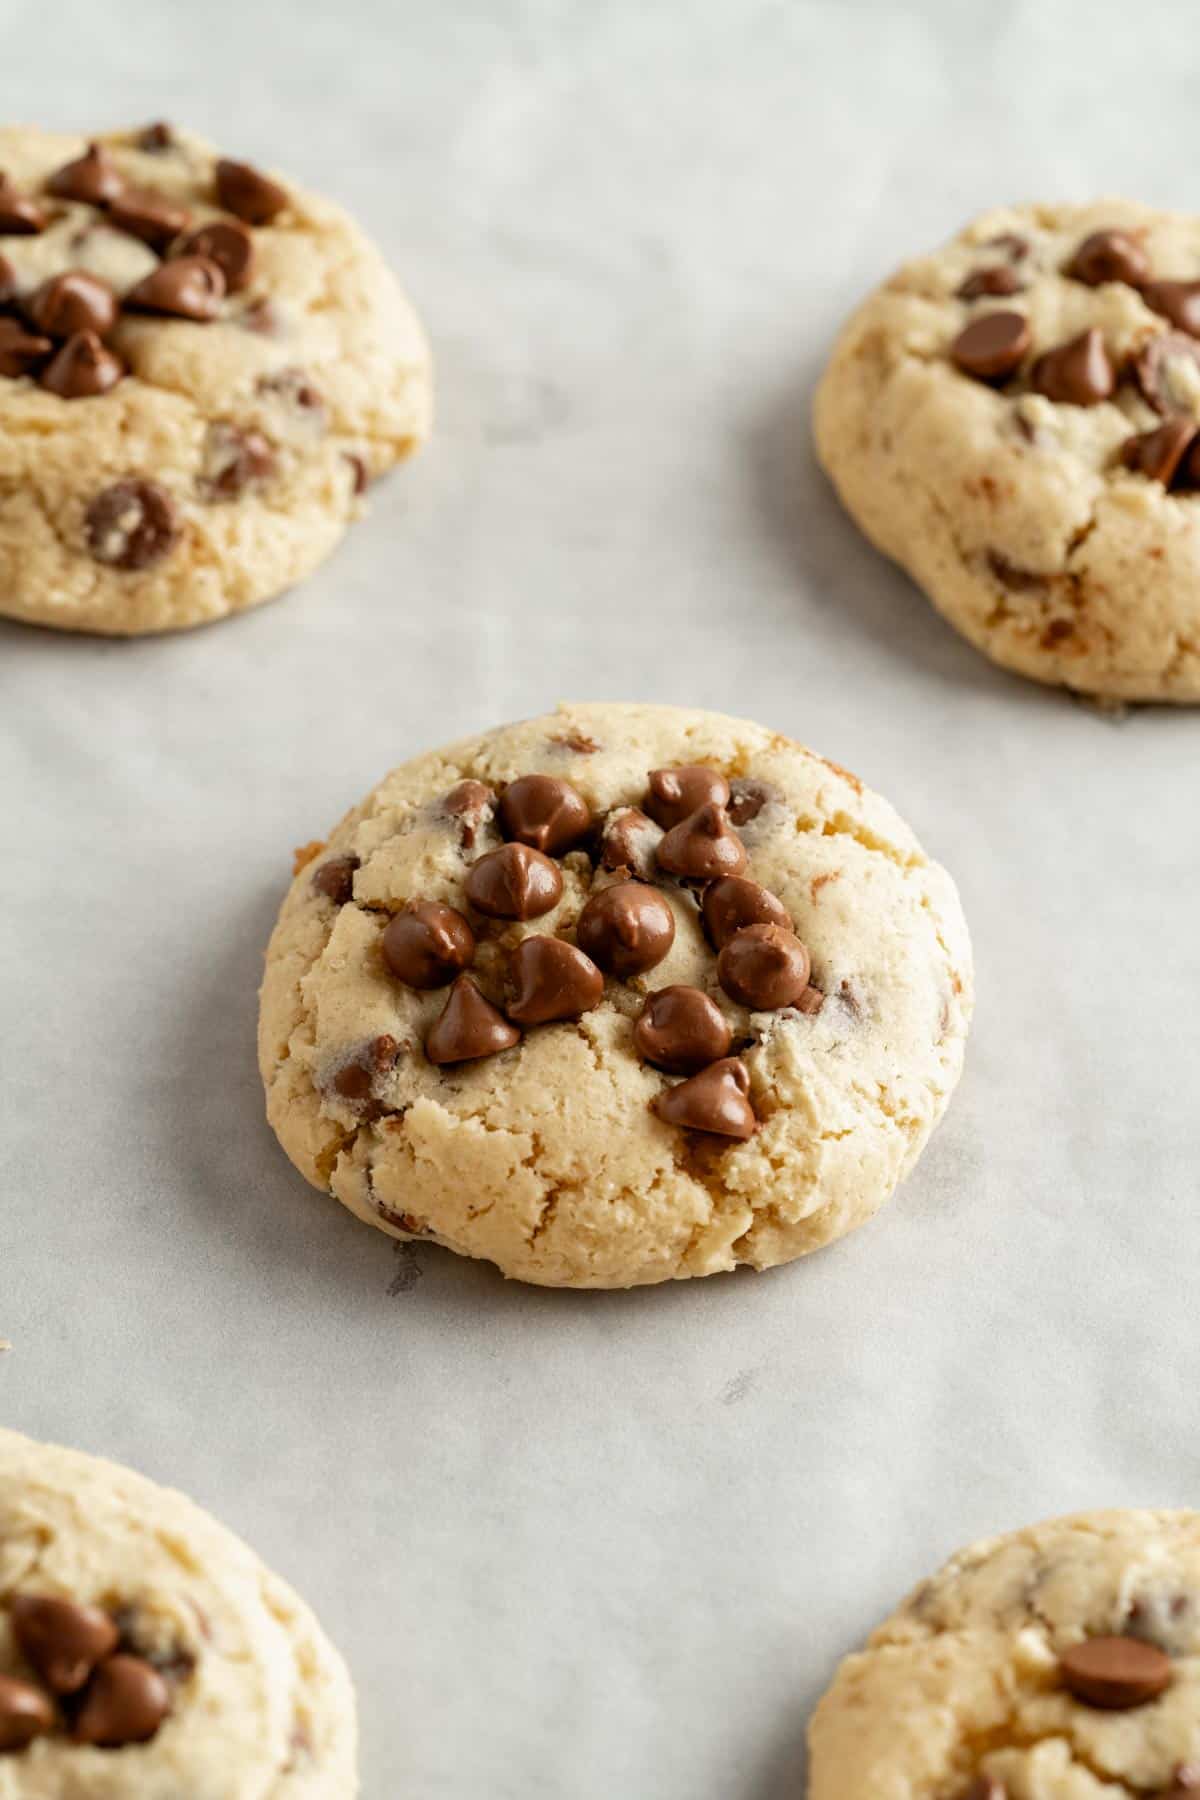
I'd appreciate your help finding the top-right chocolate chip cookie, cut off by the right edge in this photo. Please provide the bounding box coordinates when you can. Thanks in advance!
[815,200,1200,702]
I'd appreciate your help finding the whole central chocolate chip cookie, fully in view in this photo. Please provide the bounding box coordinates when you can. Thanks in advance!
[259,706,972,1287]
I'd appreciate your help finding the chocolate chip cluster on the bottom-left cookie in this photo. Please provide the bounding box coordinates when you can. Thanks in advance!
[0,1593,178,1751]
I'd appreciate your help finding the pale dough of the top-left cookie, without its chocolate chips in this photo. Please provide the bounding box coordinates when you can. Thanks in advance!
[0,128,432,635]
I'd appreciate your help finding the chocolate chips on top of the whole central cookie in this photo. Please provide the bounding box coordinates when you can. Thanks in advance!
[311,765,824,1138]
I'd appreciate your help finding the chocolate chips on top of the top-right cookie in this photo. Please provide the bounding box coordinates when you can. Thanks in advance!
[950,230,1200,491]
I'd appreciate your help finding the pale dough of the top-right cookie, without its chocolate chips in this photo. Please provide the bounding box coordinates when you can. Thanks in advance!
[815,200,1200,702]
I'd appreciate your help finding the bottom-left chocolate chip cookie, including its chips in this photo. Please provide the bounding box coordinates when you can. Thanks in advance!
[0,1429,358,1800]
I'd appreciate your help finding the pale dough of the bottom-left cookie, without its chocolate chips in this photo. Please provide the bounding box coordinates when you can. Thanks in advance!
[0,1431,358,1800]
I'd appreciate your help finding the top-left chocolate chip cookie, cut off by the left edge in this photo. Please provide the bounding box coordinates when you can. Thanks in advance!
[0,126,430,634]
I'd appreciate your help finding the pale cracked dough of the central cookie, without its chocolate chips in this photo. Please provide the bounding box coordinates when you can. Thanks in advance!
[259,706,972,1287]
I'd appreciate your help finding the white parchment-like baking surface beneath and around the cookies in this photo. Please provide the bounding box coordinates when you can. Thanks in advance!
[0,0,1200,1800]
